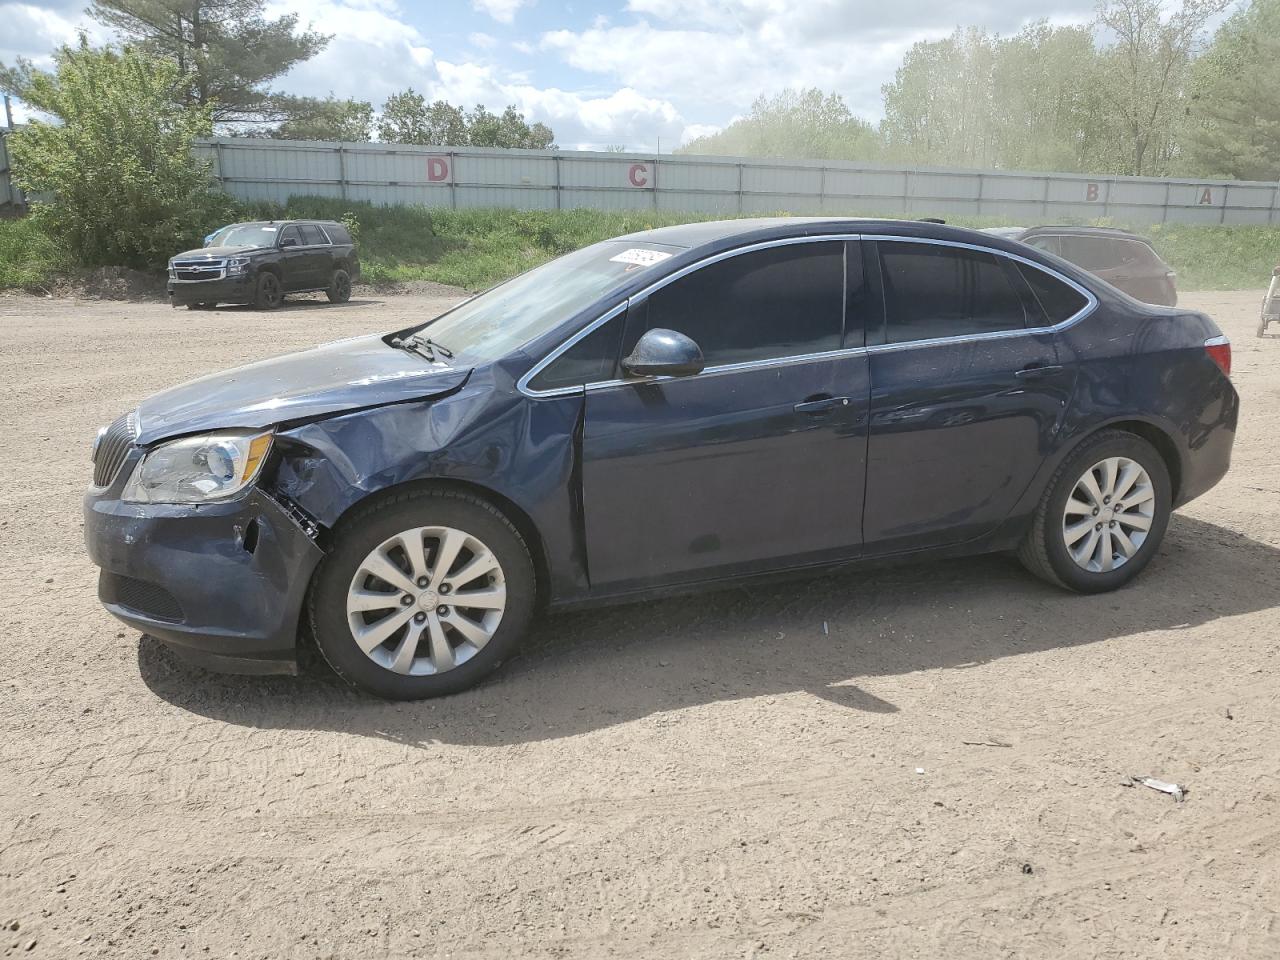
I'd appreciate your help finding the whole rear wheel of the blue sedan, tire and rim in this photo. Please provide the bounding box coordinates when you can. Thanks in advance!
[1018,430,1172,594]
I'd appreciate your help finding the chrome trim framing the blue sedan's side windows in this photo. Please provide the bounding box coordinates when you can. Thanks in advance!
[516,233,1098,399]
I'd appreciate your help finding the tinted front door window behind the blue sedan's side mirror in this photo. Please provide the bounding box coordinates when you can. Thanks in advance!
[627,241,845,366]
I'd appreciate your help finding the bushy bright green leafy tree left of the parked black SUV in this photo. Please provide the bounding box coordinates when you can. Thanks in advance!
[10,40,234,268]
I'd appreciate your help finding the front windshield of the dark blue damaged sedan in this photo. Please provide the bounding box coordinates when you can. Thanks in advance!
[419,241,673,364]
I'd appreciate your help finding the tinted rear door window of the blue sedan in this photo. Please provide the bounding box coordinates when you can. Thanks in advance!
[879,242,1027,343]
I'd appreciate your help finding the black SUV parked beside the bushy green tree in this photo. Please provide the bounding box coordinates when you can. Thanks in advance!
[169,220,360,310]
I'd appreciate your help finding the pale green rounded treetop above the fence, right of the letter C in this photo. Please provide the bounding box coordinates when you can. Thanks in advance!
[676,88,879,160]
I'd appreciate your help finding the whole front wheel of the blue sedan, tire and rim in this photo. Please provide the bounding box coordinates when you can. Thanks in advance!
[308,490,536,700]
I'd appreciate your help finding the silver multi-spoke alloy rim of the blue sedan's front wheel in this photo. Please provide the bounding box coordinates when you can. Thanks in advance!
[347,526,507,676]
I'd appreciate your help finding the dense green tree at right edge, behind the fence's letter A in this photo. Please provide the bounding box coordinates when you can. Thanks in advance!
[1188,0,1280,180]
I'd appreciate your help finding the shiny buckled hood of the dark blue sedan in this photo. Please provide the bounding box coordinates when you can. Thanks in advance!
[137,335,471,445]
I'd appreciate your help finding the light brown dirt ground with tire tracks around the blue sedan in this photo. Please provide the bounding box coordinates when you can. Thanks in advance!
[0,292,1280,960]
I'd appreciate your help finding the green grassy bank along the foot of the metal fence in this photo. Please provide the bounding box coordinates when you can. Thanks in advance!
[0,197,1280,291]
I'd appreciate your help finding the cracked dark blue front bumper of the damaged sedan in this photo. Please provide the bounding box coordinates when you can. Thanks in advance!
[84,452,324,673]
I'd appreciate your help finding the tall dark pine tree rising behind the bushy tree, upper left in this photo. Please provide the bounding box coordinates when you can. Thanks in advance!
[88,0,330,123]
